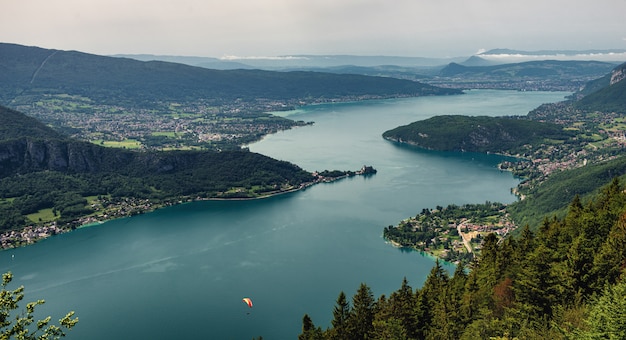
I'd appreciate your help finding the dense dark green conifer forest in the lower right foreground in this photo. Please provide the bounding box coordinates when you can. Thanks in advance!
[301,179,626,339]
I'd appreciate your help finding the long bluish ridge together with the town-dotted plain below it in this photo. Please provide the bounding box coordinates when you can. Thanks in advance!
[0,43,462,150]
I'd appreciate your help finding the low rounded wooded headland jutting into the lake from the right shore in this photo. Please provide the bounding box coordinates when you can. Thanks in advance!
[383,115,573,154]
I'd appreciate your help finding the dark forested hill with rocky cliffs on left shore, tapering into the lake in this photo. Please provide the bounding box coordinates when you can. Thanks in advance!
[0,107,313,230]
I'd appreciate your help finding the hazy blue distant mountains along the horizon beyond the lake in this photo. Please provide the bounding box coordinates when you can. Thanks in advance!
[108,49,626,91]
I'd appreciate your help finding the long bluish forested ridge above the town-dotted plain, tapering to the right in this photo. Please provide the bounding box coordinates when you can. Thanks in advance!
[0,44,460,106]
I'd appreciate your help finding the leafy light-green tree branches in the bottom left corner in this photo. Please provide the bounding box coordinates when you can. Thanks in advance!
[0,272,78,340]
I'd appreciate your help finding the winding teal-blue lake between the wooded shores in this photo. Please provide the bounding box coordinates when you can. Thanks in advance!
[0,90,569,339]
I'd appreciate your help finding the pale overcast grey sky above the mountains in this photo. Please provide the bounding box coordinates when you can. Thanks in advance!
[0,0,626,57]
